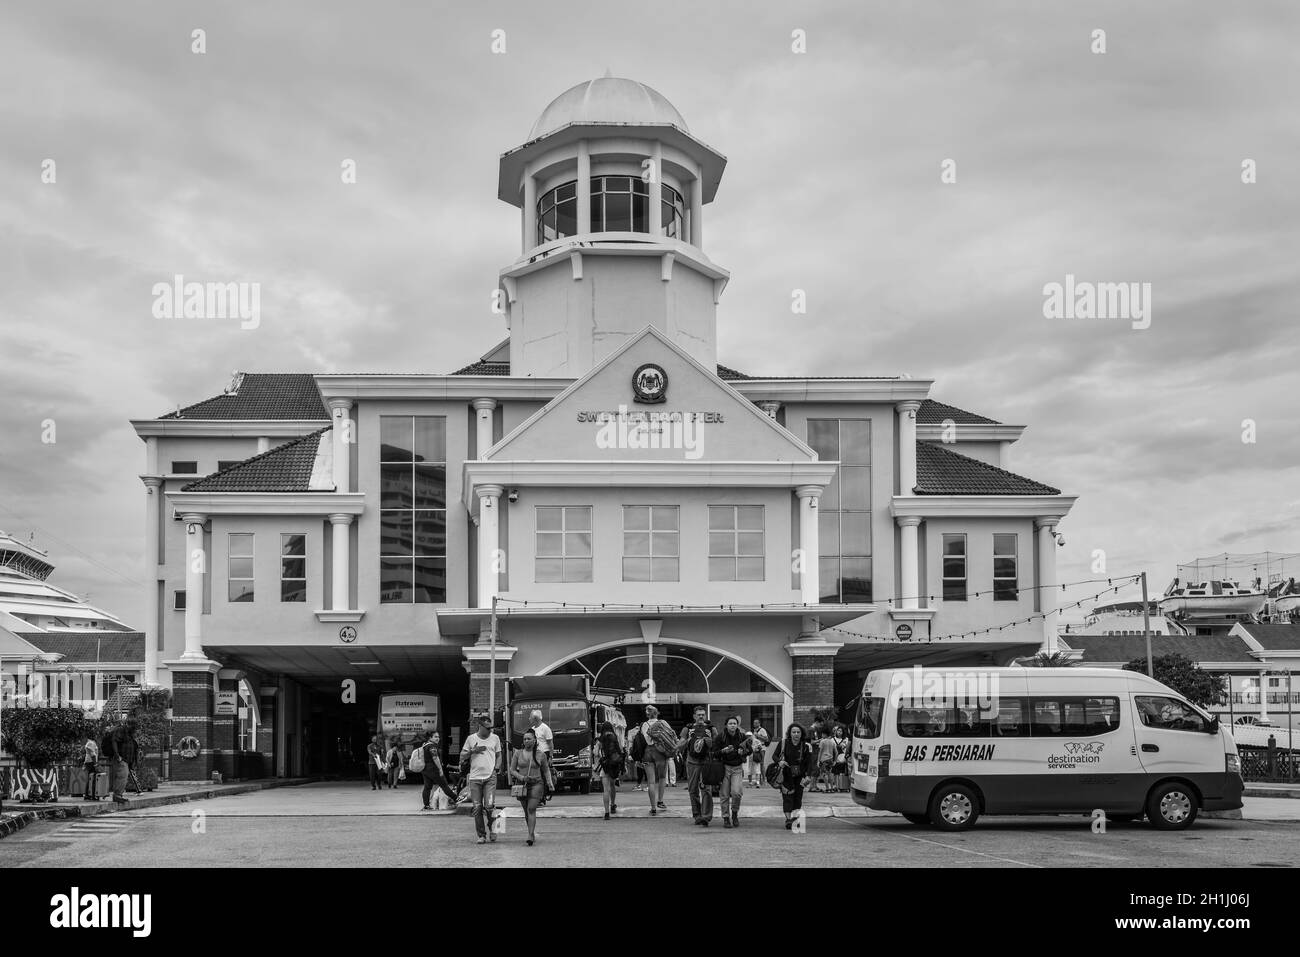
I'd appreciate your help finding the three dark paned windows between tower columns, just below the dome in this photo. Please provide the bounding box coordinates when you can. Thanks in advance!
[537,176,686,244]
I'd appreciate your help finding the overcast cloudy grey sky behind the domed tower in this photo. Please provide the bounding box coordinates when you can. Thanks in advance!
[0,0,1300,625]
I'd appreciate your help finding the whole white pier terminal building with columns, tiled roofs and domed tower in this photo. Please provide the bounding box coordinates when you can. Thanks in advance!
[133,77,1074,778]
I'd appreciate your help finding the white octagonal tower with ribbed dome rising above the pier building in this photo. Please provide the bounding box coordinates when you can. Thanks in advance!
[498,74,728,378]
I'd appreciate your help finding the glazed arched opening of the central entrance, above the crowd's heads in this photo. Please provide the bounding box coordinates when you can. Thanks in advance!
[540,638,793,733]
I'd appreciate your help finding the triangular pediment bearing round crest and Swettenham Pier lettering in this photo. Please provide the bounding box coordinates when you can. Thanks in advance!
[486,328,816,462]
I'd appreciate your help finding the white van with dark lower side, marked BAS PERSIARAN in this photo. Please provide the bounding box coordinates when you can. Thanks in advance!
[852,667,1242,831]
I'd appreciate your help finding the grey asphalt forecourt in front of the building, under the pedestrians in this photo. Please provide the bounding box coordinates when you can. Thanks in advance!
[0,783,1300,867]
